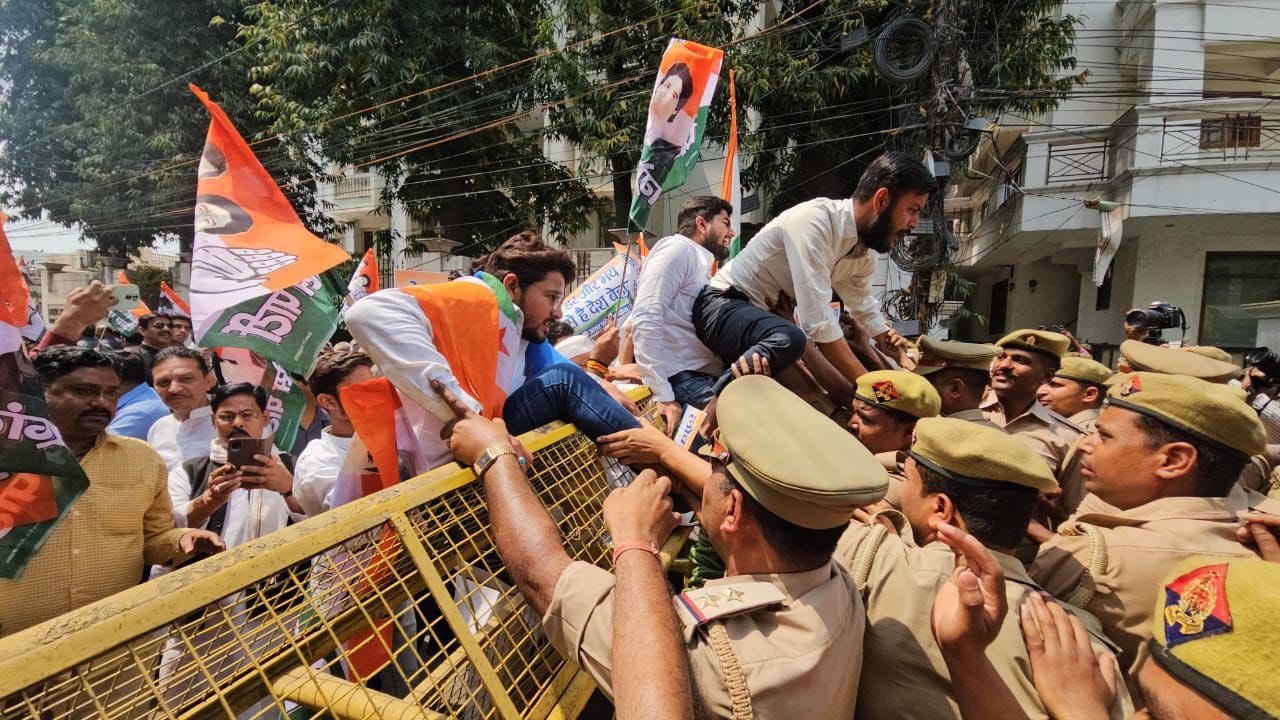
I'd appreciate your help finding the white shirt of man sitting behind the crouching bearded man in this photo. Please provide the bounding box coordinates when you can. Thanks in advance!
[630,234,724,402]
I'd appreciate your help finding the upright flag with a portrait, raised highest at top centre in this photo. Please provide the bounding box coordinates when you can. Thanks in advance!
[631,37,724,229]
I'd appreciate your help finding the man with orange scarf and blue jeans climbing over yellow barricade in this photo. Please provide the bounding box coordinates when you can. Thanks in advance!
[346,231,640,471]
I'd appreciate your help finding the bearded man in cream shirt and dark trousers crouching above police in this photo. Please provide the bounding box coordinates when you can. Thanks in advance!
[694,152,938,405]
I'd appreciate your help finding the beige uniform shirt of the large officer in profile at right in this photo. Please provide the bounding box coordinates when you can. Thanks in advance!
[1030,487,1280,670]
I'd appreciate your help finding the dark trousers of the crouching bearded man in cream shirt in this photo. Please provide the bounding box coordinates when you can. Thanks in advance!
[694,286,808,395]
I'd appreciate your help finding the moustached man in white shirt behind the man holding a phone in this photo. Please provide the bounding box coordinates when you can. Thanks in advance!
[147,347,214,473]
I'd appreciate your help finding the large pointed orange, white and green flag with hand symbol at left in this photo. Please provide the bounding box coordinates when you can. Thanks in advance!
[189,85,348,375]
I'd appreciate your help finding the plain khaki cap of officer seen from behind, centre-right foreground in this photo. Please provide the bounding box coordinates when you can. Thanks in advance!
[909,418,1057,492]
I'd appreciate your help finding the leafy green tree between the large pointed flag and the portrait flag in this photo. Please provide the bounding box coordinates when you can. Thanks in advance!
[241,0,594,254]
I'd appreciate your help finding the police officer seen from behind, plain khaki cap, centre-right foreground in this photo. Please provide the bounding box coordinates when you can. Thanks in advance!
[836,418,1132,720]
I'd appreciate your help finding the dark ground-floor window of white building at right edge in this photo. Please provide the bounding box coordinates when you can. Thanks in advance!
[1198,252,1280,347]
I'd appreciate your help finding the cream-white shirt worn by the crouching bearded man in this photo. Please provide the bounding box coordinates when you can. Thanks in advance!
[710,197,888,342]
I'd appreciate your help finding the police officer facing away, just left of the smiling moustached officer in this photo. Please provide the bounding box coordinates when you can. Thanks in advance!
[911,336,1001,429]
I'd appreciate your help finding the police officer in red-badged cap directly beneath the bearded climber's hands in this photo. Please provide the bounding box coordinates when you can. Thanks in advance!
[849,370,942,510]
